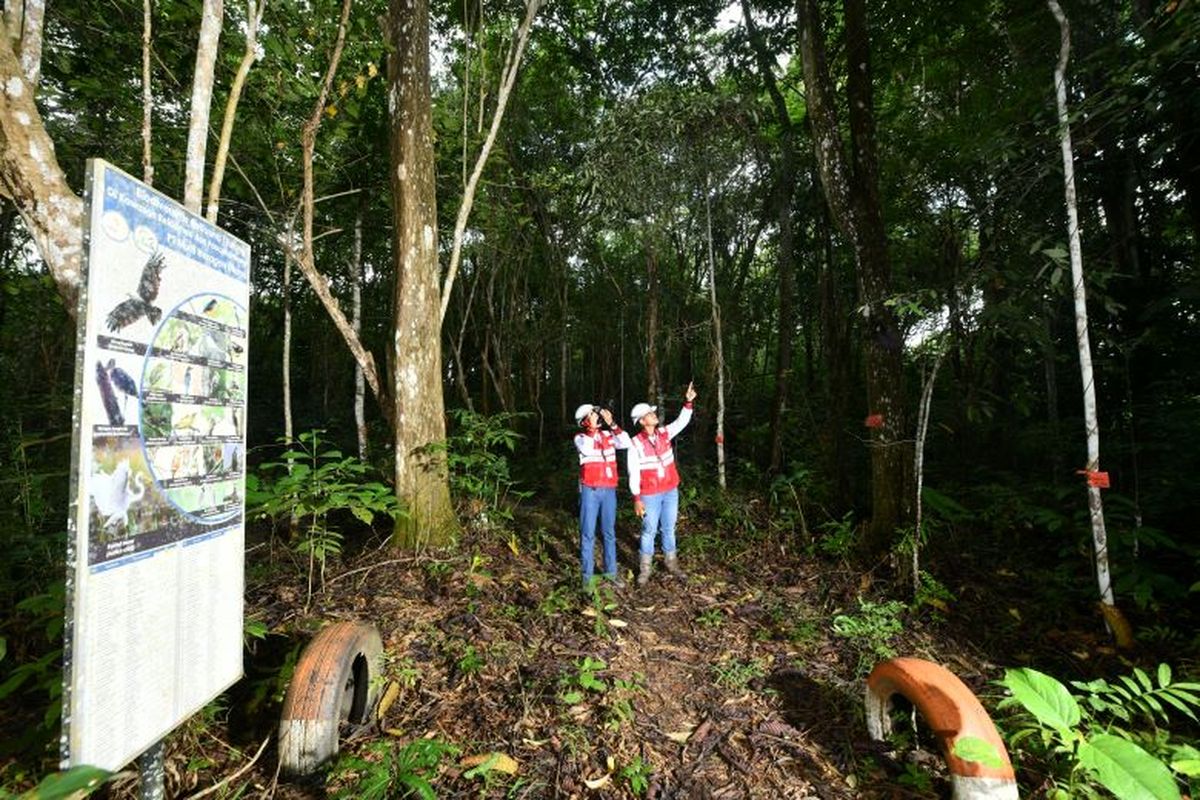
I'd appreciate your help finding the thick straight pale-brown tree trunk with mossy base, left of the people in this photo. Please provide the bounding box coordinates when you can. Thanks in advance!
[386,0,458,547]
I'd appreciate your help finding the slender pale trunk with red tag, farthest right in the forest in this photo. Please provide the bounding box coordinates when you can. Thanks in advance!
[1046,0,1114,607]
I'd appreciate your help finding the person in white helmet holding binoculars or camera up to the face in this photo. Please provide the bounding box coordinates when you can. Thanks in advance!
[575,403,629,590]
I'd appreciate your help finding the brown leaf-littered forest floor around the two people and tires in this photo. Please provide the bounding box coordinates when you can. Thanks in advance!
[63,494,1132,800]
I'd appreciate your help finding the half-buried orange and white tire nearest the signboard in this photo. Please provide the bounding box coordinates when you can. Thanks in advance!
[280,622,383,775]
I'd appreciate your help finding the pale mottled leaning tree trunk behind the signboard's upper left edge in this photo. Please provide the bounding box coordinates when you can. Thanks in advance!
[0,18,83,317]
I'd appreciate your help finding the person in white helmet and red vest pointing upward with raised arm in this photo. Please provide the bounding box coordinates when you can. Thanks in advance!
[628,383,696,587]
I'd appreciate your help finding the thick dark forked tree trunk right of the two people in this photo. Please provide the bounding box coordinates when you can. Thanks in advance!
[797,0,912,555]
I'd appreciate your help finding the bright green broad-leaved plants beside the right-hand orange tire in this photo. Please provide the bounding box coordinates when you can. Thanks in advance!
[993,664,1200,800]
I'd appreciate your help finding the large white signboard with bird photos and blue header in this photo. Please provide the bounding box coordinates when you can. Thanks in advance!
[61,161,250,777]
